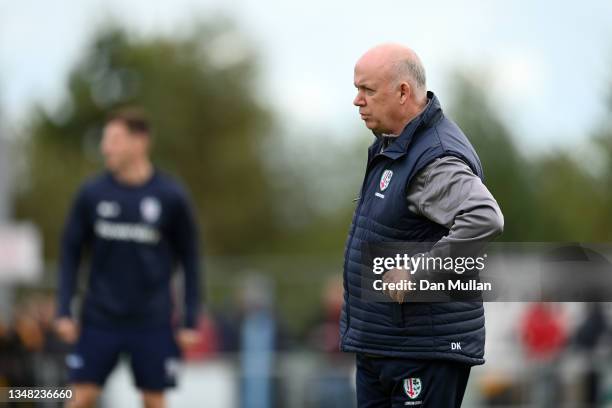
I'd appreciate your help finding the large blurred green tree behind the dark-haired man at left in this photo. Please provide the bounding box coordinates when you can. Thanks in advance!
[15,22,277,259]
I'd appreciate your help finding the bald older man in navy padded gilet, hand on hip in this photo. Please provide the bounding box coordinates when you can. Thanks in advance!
[340,44,503,408]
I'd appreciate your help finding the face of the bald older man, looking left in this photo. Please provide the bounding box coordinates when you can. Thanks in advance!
[353,57,400,134]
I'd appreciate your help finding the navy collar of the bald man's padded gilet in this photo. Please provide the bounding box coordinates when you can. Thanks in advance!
[370,91,442,160]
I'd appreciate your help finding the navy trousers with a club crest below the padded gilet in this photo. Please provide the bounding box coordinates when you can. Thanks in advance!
[357,354,470,408]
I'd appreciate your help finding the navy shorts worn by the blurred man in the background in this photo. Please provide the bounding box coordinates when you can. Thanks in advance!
[66,326,180,391]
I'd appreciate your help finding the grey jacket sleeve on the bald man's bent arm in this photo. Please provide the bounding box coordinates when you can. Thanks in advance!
[407,156,504,256]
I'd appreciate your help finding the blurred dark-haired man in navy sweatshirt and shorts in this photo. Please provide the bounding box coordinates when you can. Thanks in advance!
[56,108,199,407]
